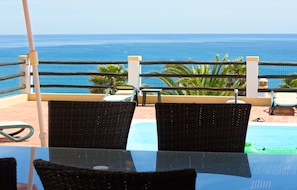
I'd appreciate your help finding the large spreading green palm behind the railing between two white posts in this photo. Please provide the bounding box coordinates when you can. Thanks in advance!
[151,54,245,96]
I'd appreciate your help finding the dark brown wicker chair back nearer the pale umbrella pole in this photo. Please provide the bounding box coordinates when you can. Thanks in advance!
[48,101,136,149]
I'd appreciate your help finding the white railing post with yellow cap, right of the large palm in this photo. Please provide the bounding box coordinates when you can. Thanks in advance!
[246,56,259,98]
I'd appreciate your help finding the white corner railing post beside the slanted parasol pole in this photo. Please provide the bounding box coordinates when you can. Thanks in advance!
[19,55,32,94]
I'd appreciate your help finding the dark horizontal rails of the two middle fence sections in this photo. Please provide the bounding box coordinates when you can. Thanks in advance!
[35,61,246,91]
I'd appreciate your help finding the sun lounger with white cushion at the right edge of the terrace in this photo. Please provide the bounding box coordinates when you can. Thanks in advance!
[269,91,297,115]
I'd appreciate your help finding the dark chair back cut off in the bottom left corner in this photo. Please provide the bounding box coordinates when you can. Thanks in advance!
[0,158,17,190]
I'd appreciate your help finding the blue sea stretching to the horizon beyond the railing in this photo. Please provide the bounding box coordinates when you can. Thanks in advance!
[0,34,297,95]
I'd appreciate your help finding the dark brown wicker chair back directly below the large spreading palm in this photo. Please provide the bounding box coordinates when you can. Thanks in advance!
[155,103,251,152]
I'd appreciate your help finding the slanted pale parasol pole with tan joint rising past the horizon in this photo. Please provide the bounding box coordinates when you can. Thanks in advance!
[23,0,47,146]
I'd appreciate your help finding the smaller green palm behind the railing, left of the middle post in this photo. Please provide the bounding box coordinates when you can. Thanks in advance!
[89,64,128,94]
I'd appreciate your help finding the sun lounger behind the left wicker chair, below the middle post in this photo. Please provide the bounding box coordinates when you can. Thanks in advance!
[102,85,138,105]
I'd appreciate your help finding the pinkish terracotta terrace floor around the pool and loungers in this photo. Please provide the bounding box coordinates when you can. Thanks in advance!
[0,101,297,146]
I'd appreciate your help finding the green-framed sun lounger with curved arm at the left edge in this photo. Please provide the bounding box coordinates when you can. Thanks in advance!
[0,121,34,142]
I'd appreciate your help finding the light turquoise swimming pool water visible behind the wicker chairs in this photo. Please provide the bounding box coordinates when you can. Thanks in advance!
[127,120,297,150]
